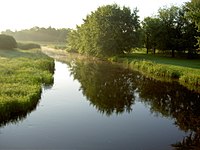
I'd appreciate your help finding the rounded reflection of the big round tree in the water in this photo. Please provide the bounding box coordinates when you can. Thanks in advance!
[68,61,136,116]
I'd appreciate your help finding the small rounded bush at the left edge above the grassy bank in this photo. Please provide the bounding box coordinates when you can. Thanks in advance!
[0,34,17,49]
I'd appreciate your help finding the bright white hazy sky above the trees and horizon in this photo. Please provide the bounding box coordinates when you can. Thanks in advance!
[0,0,190,31]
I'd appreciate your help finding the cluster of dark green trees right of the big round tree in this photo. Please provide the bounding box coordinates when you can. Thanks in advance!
[143,6,199,58]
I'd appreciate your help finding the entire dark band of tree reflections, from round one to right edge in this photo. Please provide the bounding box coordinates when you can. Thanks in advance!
[70,58,200,149]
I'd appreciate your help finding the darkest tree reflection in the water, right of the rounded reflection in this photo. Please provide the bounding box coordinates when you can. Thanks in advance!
[134,78,200,149]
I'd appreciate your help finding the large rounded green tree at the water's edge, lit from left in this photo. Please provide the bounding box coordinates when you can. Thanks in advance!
[69,4,140,56]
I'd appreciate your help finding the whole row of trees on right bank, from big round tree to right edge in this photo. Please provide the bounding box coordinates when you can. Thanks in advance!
[67,0,200,57]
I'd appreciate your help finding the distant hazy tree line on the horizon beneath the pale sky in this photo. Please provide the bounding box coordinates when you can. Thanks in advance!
[2,27,70,42]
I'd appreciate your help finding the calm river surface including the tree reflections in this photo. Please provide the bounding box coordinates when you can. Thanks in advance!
[0,61,200,150]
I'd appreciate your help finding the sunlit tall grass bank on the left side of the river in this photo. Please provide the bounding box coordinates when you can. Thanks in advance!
[0,50,54,125]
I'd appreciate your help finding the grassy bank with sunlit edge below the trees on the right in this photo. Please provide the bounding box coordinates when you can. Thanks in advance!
[110,54,200,92]
